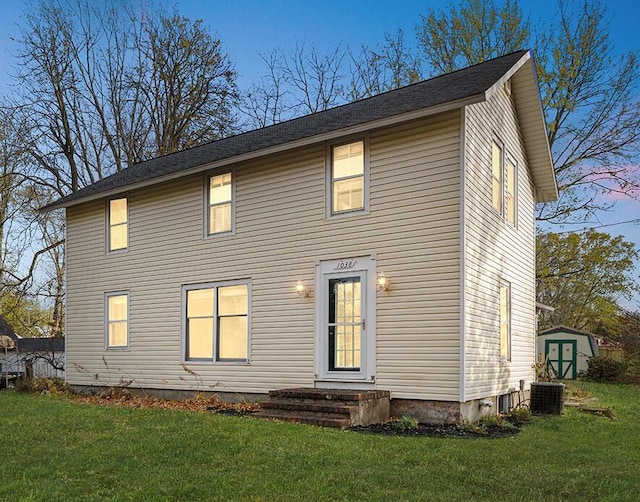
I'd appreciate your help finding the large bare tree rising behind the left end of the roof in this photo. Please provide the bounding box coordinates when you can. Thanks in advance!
[13,0,237,195]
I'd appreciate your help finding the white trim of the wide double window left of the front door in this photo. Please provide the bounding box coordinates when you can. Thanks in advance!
[180,279,251,365]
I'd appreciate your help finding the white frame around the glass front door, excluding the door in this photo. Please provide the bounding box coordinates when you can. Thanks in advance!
[315,256,376,382]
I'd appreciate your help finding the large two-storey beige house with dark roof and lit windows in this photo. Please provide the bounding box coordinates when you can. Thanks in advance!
[43,51,557,421]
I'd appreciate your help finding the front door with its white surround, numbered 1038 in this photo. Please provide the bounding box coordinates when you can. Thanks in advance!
[316,258,375,381]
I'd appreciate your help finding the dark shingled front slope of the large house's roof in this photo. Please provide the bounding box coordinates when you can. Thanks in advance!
[43,51,556,211]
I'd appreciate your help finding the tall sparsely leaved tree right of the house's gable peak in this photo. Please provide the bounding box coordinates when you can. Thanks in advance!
[536,1,640,222]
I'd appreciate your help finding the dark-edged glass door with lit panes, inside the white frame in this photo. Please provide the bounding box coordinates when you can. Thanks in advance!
[328,276,364,371]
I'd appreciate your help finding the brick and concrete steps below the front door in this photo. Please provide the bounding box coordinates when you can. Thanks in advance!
[254,388,390,428]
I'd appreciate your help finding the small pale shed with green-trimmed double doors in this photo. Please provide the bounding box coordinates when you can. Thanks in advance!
[538,326,599,380]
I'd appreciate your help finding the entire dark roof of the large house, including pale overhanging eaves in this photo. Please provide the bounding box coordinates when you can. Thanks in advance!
[42,51,558,211]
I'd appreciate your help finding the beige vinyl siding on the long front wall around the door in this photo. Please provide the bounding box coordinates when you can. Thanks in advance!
[67,111,460,400]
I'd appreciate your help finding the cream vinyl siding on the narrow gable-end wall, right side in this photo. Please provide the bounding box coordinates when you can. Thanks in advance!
[463,84,535,400]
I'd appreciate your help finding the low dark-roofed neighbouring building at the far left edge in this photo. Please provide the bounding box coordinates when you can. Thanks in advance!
[0,316,65,383]
